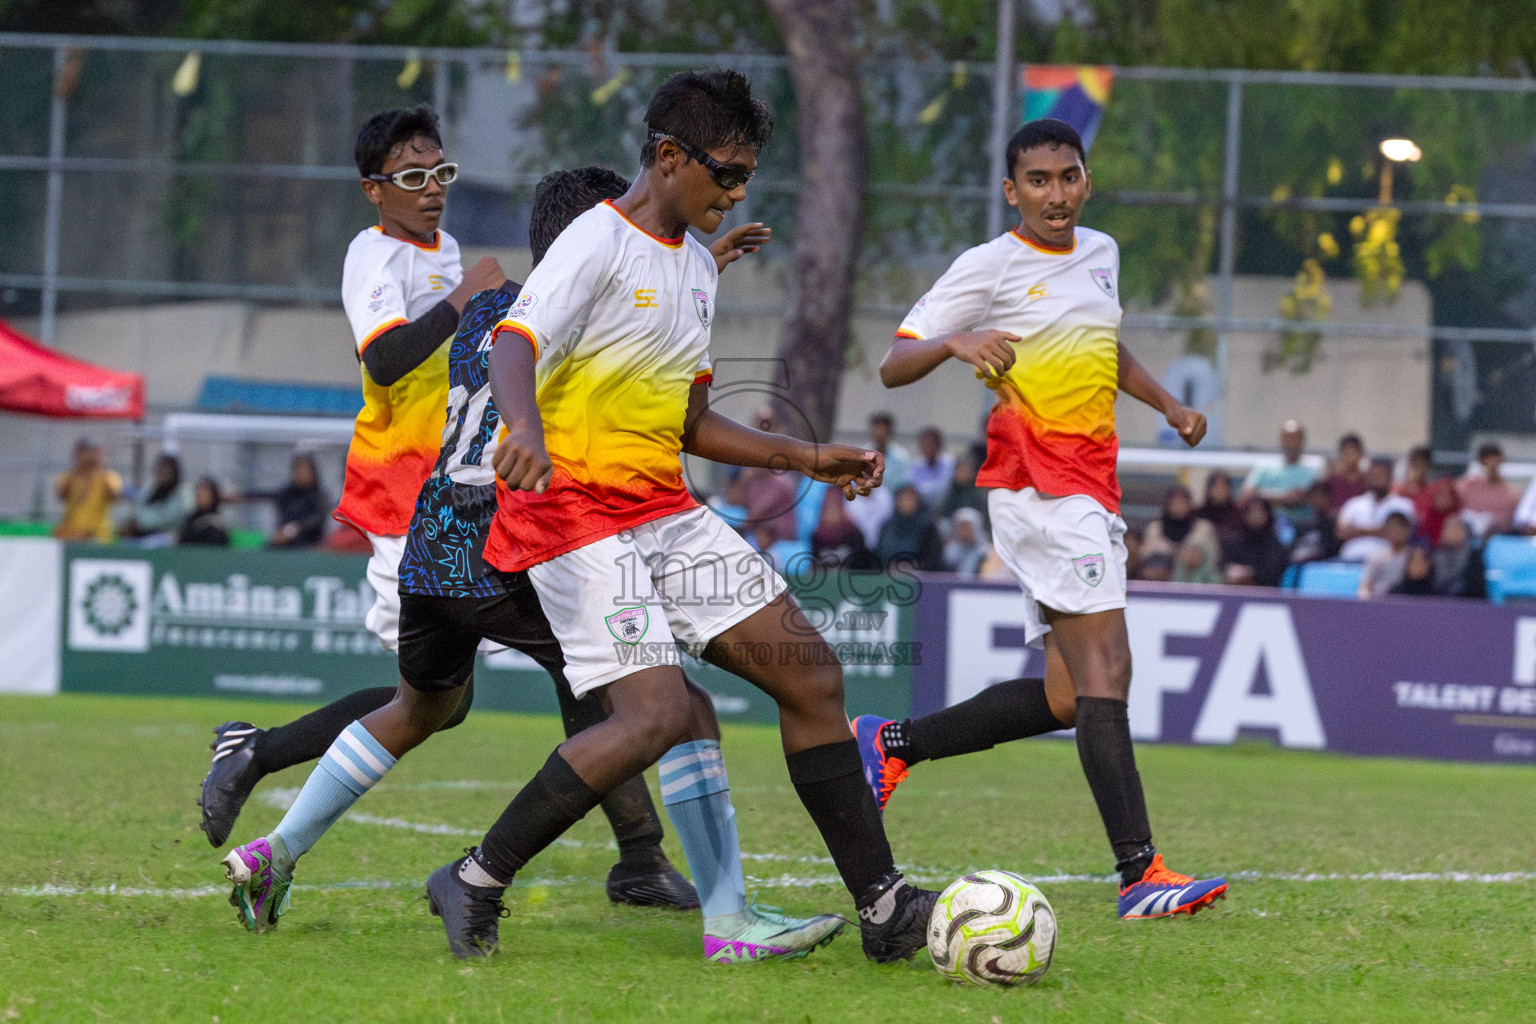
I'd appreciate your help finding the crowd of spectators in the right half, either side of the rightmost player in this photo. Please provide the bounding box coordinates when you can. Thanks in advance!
[711,410,1536,597]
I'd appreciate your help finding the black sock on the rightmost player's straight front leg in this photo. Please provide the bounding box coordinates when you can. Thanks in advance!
[1077,697,1157,886]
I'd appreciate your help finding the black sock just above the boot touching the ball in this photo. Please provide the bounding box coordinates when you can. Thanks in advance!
[783,738,895,900]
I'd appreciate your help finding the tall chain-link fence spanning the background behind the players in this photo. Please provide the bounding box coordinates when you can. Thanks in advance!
[0,35,1536,515]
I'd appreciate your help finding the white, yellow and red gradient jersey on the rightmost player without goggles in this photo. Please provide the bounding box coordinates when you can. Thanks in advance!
[897,227,1121,513]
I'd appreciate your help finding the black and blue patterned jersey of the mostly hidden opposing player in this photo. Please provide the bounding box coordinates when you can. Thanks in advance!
[399,281,524,597]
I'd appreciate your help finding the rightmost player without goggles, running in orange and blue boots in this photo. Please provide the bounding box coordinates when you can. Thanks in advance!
[854,118,1227,918]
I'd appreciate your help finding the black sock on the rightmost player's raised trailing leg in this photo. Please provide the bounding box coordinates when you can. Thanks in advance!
[880,679,1068,765]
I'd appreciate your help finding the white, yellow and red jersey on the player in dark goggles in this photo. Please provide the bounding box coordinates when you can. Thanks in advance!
[485,203,719,571]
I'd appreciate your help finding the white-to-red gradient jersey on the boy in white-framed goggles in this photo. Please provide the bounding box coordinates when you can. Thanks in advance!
[335,227,464,536]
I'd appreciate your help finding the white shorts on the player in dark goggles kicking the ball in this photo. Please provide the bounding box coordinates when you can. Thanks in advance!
[528,508,785,697]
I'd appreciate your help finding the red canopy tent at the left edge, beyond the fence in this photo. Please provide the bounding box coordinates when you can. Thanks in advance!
[0,321,144,419]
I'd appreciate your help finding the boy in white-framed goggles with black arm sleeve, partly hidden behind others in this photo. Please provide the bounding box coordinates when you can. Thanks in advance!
[198,104,718,909]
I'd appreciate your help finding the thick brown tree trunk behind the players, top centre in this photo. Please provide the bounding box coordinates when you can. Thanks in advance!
[766,0,869,442]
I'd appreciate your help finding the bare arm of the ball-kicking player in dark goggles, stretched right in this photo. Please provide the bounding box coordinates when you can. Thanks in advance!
[682,384,885,500]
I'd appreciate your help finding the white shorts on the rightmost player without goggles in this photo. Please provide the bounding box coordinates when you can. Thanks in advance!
[986,487,1126,648]
